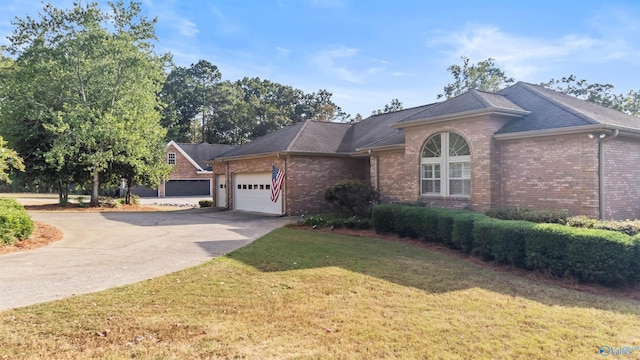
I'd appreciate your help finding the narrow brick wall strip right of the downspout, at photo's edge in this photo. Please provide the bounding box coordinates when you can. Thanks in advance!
[603,137,640,220]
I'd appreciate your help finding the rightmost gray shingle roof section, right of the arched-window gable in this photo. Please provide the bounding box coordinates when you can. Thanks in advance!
[497,82,640,134]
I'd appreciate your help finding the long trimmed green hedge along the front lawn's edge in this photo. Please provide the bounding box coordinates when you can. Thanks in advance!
[372,205,640,285]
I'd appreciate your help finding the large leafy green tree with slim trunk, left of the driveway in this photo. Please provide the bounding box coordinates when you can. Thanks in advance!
[0,1,169,206]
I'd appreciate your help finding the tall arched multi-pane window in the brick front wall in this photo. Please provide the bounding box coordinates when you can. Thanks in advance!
[420,132,471,197]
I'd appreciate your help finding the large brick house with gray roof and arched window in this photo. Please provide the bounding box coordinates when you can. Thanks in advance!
[212,82,640,219]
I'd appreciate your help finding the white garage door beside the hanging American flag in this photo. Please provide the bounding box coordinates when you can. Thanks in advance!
[233,173,283,215]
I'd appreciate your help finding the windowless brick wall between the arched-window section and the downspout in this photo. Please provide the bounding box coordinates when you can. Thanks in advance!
[497,134,599,217]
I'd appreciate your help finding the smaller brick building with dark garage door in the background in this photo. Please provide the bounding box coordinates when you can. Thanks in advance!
[133,141,236,197]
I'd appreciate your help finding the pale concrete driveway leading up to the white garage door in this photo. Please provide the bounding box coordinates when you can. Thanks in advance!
[0,208,291,310]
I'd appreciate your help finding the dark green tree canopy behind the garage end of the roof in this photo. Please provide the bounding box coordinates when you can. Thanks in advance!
[160,64,350,145]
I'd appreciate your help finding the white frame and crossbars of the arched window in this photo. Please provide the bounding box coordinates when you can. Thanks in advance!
[420,131,471,199]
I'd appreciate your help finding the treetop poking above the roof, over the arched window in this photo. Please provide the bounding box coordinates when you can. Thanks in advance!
[438,56,515,99]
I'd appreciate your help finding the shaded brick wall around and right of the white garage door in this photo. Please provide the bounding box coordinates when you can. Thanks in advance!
[213,156,369,215]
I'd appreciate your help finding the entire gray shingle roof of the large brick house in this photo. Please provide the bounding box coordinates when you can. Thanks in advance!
[217,82,640,158]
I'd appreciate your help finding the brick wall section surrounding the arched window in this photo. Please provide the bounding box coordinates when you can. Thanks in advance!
[405,115,509,211]
